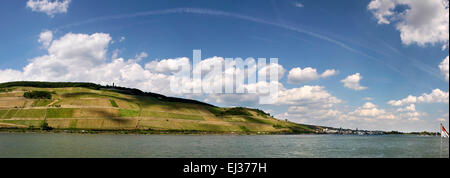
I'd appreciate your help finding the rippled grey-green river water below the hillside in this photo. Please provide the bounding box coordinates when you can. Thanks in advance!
[0,133,449,158]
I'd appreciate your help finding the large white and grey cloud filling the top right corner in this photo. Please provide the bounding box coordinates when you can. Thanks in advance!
[367,0,449,46]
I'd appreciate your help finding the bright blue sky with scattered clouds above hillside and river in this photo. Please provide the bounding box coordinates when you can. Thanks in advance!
[0,0,449,131]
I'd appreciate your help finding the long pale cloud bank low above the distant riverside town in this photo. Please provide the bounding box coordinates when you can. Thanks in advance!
[282,99,435,131]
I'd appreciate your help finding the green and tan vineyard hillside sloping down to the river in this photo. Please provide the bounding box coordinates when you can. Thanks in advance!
[0,82,319,133]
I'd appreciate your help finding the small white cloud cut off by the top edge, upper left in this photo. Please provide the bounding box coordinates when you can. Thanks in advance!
[27,0,71,17]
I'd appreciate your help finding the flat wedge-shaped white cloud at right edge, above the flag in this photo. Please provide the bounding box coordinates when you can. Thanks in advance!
[388,89,449,106]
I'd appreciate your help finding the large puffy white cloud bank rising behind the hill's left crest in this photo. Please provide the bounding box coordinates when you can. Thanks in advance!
[0,31,270,98]
